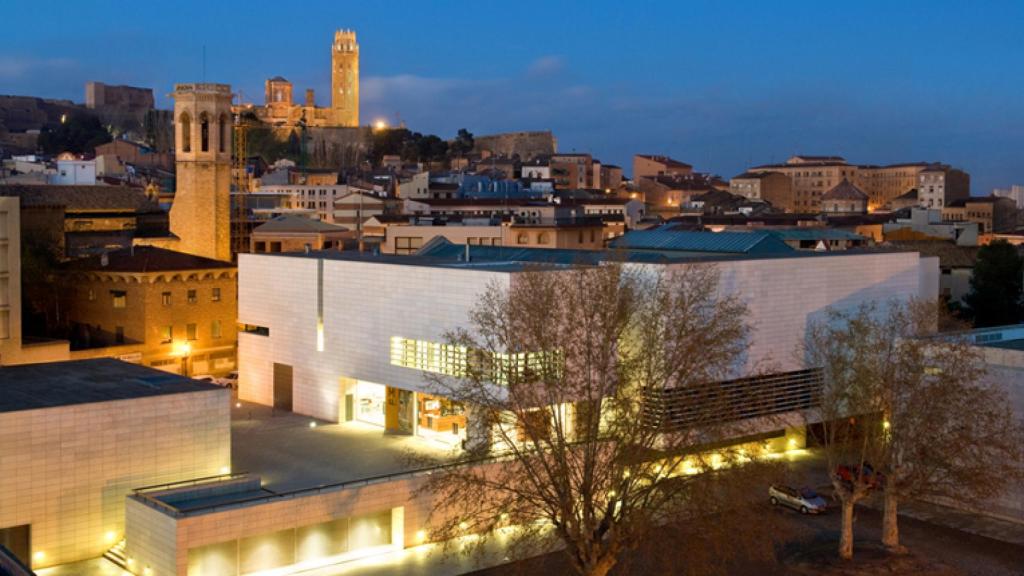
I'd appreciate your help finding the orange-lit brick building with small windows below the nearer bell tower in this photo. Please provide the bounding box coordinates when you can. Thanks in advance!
[62,246,238,375]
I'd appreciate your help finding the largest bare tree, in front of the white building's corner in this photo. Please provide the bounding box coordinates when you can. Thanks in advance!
[425,263,786,575]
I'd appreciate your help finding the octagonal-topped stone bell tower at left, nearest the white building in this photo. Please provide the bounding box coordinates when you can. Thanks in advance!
[170,84,232,261]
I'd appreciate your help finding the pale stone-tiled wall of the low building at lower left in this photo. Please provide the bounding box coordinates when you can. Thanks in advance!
[0,389,231,569]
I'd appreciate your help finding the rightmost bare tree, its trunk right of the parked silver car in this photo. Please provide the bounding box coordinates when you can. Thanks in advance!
[879,301,1024,550]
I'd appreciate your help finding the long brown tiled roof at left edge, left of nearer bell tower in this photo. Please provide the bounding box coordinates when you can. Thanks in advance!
[0,184,160,212]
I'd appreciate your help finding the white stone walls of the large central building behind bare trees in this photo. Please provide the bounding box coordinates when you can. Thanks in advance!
[239,252,938,421]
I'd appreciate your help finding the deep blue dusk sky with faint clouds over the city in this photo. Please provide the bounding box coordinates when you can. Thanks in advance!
[0,0,1024,195]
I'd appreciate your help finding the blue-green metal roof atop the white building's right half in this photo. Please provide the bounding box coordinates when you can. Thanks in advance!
[611,224,793,254]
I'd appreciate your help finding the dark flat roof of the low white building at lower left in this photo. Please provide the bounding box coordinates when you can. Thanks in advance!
[0,358,223,412]
